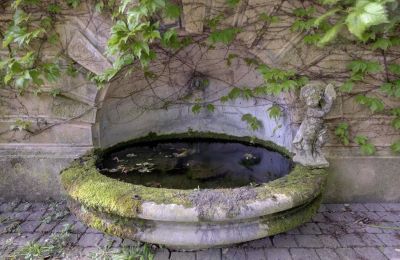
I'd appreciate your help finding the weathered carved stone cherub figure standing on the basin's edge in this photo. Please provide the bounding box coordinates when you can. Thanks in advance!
[293,83,336,168]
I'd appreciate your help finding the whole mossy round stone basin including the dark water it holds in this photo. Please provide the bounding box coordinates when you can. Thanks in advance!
[61,132,326,250]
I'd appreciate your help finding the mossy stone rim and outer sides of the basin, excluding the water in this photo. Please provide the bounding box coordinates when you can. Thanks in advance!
[61,133,326,249]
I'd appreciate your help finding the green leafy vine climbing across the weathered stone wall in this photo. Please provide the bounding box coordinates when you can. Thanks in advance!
[0,0,400,155]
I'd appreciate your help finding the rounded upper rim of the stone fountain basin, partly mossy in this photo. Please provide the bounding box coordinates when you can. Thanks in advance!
[61,132,326,222]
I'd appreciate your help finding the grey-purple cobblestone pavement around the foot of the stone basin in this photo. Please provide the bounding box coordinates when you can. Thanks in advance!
[0,199,400,260]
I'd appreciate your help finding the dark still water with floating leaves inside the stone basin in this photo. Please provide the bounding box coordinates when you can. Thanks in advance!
[98,139,292,189]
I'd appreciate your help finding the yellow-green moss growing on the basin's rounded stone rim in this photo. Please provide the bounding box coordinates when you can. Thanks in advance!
[61,132,326,217]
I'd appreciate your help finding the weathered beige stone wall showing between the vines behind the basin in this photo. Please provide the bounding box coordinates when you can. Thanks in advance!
[0,0,400,202]
